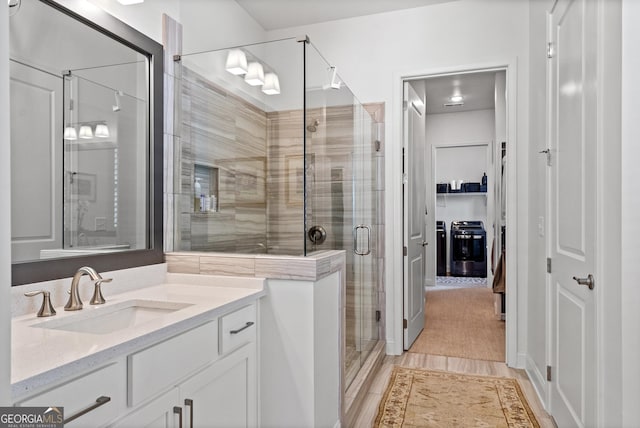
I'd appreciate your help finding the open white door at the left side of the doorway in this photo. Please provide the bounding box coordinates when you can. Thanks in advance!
[403,82,427,349]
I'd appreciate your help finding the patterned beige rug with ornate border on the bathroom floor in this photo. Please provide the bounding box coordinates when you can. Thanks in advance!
[374,366,540,428]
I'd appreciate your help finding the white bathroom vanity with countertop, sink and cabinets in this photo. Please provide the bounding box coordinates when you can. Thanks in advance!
[12,273,265,427]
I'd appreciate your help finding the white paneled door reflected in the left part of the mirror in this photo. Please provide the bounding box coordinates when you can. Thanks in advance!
[10,61,62,261]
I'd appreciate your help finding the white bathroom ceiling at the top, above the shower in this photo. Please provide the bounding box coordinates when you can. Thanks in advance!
[236,0,455,31]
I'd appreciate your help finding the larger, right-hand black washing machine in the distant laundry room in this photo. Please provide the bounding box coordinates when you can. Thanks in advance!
[451,221,487,278]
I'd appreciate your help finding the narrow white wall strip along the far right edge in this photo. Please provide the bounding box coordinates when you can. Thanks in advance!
[621,0,640,427]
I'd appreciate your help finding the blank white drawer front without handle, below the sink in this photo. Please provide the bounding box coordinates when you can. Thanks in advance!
[127,320,218,406]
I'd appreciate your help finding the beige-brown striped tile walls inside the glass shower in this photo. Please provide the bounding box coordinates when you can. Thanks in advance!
[175,67,380,263]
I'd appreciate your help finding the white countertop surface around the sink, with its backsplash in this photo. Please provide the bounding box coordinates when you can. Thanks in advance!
[11,274,266,398]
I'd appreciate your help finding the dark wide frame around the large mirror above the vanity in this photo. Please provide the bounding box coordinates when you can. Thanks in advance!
[11,0,164,286]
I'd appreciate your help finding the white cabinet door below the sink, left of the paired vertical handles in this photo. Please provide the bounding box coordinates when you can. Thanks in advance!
[112,389,184,428]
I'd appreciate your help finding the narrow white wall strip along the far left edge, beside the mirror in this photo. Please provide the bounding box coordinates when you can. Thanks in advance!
[0,0,11,406]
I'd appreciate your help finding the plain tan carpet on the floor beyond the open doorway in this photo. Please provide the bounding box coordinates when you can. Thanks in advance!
[409,288,505,362]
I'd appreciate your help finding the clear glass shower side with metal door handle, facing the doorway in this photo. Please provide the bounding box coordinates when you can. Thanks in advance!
[305,45,379,388]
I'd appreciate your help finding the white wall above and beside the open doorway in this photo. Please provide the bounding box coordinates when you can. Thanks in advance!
[269,0,529,353]
